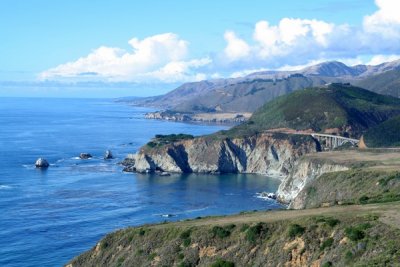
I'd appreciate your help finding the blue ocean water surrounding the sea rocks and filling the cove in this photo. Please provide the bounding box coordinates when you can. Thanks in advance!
[0,98,281,266]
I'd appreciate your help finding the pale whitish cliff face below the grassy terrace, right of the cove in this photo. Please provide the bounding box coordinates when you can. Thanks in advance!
[277,158,349,209]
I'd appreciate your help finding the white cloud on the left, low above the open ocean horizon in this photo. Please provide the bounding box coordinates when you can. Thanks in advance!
[39,33,211,82]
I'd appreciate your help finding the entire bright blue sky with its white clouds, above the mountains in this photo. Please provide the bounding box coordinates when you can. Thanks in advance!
[0,0,400,97]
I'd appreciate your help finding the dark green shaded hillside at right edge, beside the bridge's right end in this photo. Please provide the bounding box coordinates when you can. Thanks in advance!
[364,116,400,147]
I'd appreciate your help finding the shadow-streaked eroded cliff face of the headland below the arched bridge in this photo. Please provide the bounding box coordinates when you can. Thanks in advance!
[125,133,318,179]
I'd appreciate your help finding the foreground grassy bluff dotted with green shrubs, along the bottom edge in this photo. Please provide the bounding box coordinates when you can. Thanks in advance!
[71,203,400,266]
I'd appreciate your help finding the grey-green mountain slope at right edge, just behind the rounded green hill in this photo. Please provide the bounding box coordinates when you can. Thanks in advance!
[353,69,400,97]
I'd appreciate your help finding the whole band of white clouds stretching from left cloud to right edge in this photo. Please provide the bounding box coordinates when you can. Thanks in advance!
[39,0,400,83]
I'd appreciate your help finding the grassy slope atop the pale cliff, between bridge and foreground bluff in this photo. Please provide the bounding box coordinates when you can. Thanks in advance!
[295,149,400,208]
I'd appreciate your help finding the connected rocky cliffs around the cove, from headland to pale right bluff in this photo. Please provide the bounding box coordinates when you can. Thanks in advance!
[122,133,348,209]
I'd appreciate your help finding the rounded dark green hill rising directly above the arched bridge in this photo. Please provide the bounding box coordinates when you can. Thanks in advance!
[223,84,400,138]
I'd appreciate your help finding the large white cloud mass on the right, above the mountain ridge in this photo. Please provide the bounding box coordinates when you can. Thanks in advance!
[224,0,400,72]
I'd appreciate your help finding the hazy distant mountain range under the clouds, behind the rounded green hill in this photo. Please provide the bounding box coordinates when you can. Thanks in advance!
[127,60,400,114]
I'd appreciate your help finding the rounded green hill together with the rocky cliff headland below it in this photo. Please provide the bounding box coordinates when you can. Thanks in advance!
[126,84,400,175]
